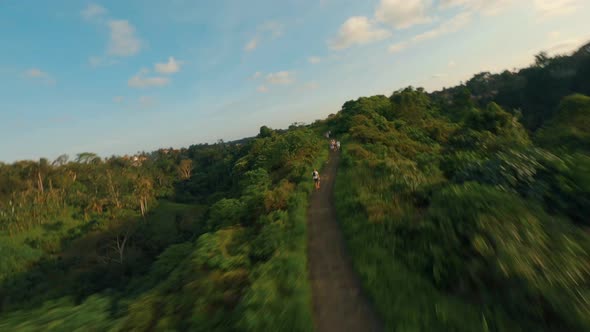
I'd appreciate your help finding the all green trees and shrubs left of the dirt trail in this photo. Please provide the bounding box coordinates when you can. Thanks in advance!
[0,125,326,331]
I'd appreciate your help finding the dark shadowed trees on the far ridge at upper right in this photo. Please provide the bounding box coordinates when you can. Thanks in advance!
[432,44,590,130]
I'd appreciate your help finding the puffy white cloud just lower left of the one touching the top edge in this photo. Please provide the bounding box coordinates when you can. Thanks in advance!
[330,16,391,50]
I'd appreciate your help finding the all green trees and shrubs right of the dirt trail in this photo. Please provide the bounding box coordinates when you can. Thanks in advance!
[332,43,590,331]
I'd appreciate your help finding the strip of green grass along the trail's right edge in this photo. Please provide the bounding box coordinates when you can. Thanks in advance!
[335,158,486,331]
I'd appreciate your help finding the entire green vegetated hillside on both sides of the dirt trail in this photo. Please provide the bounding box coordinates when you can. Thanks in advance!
[0,44,590,331]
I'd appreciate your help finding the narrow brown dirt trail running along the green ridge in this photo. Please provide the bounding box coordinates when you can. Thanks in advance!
[307,152,383,332]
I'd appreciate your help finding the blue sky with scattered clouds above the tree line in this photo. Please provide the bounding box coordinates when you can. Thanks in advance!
[0,0,590,162]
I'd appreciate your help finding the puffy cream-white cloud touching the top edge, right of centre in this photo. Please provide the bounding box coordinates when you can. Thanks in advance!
[375,0,432,29]
